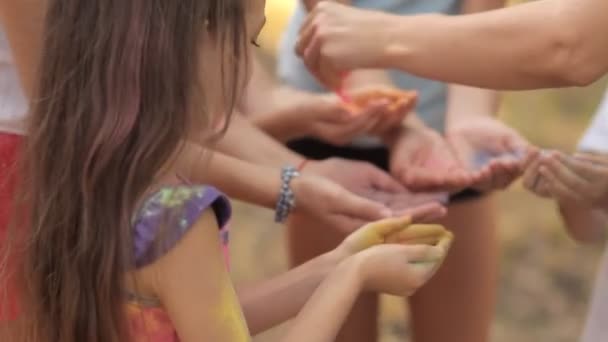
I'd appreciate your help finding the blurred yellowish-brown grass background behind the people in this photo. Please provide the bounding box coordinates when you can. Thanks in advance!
[232,0,606,342]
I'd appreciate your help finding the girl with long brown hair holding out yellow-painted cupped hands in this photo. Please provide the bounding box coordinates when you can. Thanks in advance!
[3,0,451,342]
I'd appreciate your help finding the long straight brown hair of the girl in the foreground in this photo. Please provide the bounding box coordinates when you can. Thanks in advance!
[2,0,247,342]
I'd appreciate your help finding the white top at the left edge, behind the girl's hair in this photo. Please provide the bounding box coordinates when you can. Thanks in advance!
[0,30,28,134]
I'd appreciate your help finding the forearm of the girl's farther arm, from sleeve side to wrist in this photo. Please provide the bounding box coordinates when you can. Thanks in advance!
[237,252,340,335]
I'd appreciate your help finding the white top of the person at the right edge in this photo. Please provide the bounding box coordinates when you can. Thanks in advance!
[579,92,608,342]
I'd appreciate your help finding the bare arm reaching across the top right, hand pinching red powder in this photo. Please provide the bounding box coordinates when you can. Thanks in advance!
[299,0,608,89]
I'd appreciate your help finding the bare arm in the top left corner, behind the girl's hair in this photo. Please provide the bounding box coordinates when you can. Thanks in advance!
[0,0,47,98]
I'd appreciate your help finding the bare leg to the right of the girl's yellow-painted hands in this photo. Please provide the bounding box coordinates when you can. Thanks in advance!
[410,196,498,342]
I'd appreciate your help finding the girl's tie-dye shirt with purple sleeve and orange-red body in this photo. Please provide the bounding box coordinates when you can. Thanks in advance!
[127,185,231,342]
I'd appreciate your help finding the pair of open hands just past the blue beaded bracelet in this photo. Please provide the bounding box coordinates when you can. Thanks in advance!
[290,158,445,232]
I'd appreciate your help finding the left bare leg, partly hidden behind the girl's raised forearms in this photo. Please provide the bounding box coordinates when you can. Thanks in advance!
[287,216,378,342]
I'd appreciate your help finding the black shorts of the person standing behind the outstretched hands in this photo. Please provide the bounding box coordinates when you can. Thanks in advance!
[287,138,484,202]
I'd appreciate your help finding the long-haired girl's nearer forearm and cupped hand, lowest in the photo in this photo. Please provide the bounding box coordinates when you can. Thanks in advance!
[283,218,452,342]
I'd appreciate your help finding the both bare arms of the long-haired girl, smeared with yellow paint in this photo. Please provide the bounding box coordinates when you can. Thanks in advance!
[154,214,452,342]
